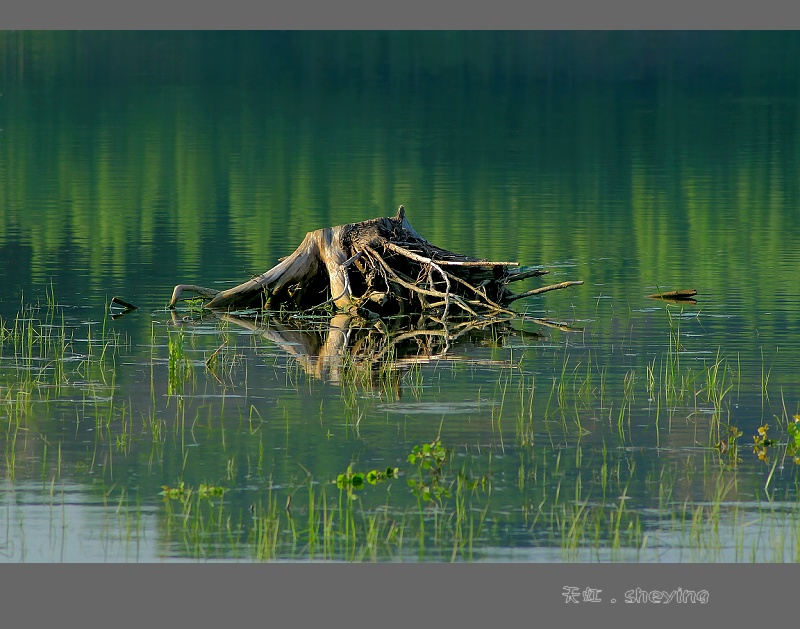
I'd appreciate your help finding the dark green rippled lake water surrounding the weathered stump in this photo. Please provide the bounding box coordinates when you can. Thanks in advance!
[0,32,800,561]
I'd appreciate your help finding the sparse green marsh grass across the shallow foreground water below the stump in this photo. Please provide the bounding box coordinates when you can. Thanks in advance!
[0,292,800,561]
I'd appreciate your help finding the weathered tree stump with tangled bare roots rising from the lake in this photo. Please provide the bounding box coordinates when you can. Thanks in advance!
[169,205,583,320]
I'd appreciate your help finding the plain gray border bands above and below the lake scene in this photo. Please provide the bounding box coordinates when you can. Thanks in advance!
[0,0,800,627]
